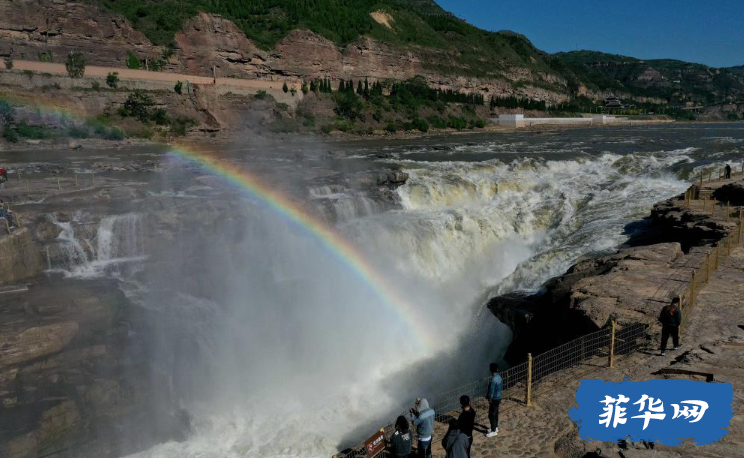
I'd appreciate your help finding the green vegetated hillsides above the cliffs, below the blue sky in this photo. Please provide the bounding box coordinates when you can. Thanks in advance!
[88,0,744,104]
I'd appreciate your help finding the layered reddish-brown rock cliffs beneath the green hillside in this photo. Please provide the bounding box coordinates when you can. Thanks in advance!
[0,0,568,102]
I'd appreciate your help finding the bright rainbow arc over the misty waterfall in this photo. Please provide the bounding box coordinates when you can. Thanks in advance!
[169,146,436,352]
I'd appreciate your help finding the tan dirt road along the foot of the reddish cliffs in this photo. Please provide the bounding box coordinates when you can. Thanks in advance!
[13,60,300,90]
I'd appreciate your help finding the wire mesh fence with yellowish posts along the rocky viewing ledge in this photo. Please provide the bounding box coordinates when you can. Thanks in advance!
[335,175,744,458]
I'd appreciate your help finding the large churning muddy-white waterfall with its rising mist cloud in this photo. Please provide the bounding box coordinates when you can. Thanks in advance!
[120,143,693,458]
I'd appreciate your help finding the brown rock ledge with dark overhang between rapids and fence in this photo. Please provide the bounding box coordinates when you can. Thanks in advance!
[488,177,744,362]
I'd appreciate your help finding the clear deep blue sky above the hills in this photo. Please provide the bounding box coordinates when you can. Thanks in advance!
[435,0,744,67]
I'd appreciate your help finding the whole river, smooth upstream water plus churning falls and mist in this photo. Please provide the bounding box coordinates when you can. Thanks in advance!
[11,124,744,458]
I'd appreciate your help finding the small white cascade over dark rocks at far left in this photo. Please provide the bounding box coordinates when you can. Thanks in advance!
[46,213,145,278]
